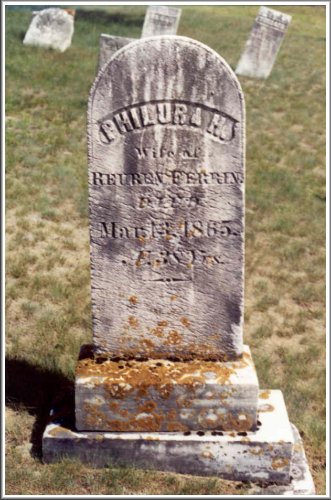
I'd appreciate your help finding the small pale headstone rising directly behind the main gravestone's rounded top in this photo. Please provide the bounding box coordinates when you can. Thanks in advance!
[141,5,182,38]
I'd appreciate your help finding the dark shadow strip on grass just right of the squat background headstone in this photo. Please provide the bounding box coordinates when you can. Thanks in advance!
[75,9,144,28]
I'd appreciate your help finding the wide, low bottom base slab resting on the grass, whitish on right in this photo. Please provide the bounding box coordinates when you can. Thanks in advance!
[43,391,313,494]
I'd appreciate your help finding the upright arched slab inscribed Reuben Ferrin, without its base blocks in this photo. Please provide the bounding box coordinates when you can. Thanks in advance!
[88,36,245,360]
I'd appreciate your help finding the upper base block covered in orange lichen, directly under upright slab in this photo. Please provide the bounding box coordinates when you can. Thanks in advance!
[75,346,258,432]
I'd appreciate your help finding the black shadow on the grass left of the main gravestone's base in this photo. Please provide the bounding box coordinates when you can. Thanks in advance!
[5,358,74,458]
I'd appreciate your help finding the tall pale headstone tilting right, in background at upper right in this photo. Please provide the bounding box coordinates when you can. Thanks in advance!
[236,7,292,78]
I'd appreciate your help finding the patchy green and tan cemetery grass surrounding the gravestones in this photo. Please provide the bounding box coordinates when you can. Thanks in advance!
[6,5,326,495]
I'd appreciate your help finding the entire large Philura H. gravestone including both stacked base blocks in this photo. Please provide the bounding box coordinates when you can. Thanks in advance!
[43,36,313,493]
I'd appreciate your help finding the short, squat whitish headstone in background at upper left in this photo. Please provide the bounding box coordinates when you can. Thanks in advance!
[23,8,75,52]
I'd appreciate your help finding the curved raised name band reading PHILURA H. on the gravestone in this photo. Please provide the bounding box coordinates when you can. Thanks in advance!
[99,101,237,144]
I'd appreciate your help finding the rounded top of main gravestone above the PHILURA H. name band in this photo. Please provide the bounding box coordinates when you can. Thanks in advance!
[89,35,244,125]
